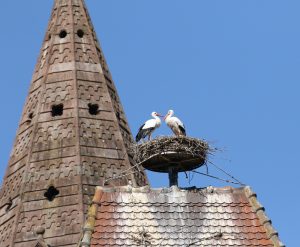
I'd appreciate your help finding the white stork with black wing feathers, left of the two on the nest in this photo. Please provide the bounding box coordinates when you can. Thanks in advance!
[135,112,161,142]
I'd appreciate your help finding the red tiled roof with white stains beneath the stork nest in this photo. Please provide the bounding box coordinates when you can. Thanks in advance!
[81,186,284,247]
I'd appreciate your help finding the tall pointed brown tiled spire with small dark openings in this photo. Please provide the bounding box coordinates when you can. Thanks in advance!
[0,0,147,247]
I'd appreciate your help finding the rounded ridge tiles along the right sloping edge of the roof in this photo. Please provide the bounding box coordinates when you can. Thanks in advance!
[243,186,285,247]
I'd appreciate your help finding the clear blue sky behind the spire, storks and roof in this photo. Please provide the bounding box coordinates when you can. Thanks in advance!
[0,0,300,247]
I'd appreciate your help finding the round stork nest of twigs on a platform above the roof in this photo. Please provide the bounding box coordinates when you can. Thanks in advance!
[132,136,212,173]
